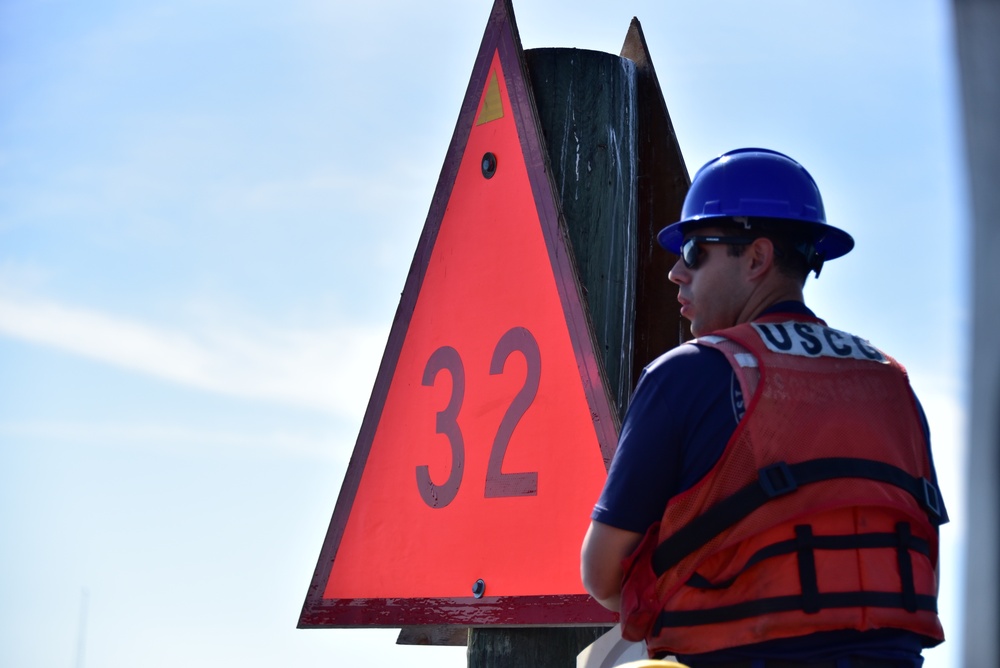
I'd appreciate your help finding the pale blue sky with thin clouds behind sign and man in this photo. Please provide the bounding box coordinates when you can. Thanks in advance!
[0,0,969,668]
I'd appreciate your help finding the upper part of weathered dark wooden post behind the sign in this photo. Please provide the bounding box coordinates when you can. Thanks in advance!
[524,49,637,416]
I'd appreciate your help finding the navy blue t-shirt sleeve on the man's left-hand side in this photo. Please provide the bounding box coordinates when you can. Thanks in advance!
[591,345,742,533]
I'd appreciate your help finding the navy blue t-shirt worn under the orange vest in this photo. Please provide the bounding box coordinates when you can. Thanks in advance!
[591,302,936,666]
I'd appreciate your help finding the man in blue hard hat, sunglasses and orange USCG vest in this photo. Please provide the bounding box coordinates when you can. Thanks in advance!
[581,149,947,668]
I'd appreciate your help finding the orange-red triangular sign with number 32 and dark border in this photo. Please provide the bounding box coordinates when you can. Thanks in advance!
[299,0,617,627]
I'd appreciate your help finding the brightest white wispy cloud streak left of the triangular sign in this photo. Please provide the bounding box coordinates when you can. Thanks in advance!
[0,295,386,419]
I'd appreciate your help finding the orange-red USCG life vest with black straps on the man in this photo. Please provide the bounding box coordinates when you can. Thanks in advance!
[621,315,947,656]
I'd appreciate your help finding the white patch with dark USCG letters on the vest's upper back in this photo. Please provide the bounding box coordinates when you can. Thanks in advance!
[751,321,889,364]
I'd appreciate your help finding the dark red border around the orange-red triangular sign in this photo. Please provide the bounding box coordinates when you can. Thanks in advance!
[298,0,619,628]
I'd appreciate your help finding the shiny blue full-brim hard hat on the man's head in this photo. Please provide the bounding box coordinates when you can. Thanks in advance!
[656,148,854,260]
